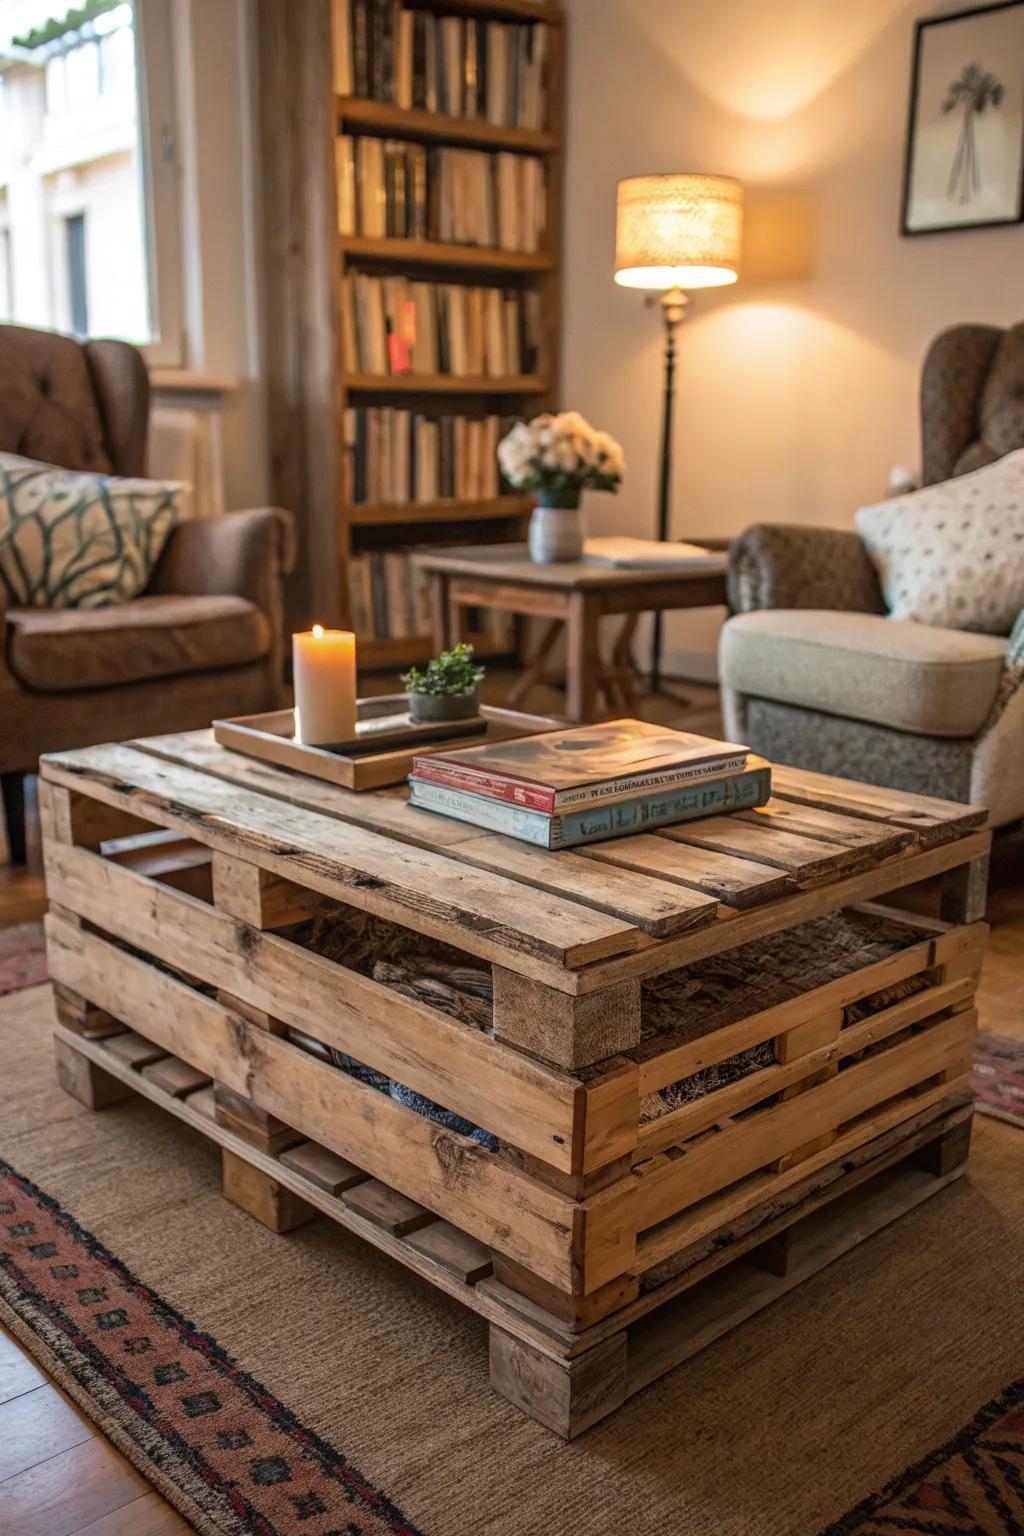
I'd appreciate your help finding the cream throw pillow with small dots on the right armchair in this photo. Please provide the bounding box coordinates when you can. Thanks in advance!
[857,449,1024,634]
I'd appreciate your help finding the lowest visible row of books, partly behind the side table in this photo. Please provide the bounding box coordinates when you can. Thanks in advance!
[348,548,514,650]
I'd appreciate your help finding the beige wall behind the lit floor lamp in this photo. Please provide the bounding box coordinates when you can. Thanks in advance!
[562,0,1024,676]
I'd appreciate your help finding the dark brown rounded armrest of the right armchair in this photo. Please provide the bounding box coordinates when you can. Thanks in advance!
[728,522,886,613]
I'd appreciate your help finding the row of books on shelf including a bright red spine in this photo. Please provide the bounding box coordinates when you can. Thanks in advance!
[342,272,542,379]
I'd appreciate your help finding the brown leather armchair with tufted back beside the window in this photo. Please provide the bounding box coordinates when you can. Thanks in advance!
[0,326,293,863]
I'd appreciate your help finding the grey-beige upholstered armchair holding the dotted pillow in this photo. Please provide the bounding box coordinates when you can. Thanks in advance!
[720,324,1024,826]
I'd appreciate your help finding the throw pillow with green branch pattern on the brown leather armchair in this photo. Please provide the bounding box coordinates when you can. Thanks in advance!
[0,453,192,608]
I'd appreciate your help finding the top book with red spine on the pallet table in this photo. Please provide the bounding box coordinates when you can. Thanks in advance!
[413,720,748,816]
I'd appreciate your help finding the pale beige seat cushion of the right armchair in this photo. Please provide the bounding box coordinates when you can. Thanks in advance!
[720,610,1007,737]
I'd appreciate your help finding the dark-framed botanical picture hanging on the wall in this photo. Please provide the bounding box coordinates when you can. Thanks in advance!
[901,0,1024,235]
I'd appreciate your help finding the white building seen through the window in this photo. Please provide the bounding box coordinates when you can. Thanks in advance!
[0,0,150,343]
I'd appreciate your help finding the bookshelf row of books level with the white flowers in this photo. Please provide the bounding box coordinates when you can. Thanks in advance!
[345,406,514,504]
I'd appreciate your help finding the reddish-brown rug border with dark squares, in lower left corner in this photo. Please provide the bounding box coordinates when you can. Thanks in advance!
[0,1160,421,1536]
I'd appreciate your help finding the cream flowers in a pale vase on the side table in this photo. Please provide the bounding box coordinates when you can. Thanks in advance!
[497,410,626,565]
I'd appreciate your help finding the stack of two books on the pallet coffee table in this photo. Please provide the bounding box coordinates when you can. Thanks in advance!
[408,720,771,848]
